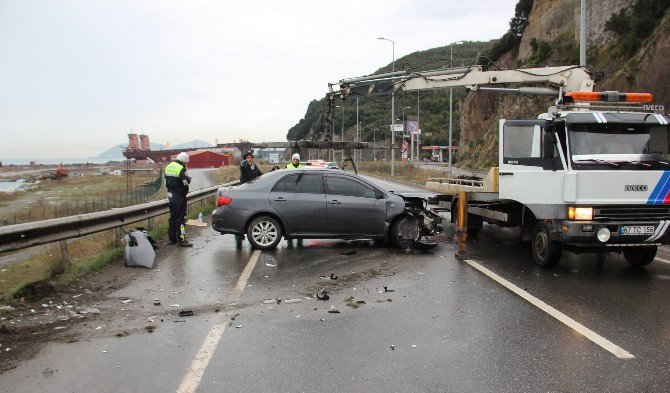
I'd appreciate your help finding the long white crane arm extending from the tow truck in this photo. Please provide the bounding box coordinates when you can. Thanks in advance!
[328,66,594,99]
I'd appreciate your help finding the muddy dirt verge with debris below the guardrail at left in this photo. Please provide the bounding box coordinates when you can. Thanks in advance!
[0,234,178,373]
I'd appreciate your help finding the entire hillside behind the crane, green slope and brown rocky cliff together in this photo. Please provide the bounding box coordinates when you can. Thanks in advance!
[287,0,670,169]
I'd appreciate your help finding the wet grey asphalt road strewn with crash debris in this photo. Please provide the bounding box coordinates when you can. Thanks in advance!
[0,173,670,392]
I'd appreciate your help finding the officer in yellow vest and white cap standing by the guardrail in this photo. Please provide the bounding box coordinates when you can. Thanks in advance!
[165,152,193,247]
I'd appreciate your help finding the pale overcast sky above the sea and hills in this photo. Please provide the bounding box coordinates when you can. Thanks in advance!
[0,0,517,162]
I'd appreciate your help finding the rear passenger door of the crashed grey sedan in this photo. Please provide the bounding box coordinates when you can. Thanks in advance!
[270,173,326,236]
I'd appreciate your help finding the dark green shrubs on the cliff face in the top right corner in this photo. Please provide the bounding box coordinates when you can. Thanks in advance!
[605,0,670,58]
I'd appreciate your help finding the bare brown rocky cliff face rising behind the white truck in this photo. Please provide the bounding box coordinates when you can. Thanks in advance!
[458,0,670,169]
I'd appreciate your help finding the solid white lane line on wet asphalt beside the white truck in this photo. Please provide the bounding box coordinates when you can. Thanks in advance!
[465,259,635,359]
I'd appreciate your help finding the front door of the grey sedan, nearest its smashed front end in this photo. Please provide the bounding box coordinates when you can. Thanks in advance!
[324,174,386,236]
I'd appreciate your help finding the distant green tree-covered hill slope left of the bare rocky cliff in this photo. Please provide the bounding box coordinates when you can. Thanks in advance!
[286,40,496,157]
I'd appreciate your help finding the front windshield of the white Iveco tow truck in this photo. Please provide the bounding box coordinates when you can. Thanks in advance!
[568,123,670,169]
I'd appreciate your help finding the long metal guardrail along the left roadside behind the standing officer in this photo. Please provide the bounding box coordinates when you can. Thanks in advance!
[0,181,239,252]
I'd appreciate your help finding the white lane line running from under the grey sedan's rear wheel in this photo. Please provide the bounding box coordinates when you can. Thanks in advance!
[177,250,261,393]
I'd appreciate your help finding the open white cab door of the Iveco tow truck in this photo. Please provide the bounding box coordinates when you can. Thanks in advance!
[498,120,565,210]
